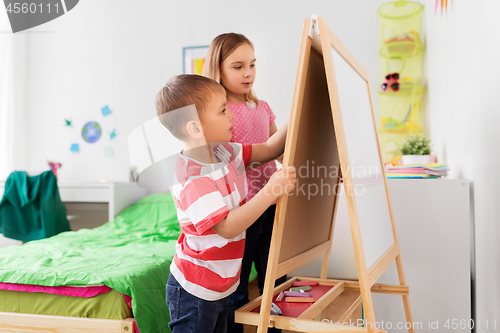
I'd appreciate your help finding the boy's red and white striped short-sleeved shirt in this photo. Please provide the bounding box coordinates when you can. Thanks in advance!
[170,143,252,301]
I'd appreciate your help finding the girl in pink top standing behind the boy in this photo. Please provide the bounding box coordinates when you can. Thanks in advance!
[203,33,286,333]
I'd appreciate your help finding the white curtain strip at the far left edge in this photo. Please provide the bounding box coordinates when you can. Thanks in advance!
[0,10,13,180]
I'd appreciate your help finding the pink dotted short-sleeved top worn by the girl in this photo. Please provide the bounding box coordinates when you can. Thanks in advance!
[227,100,277,201]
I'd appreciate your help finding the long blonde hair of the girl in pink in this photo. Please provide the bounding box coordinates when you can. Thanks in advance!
[203,32,259,105]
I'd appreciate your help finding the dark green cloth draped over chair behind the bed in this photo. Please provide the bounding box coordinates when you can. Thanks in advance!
[0,171,70,242]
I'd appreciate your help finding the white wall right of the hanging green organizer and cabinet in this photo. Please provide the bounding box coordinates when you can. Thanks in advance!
[425,0,500,332]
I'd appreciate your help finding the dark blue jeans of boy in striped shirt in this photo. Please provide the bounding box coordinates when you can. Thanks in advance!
[167,274,229,333]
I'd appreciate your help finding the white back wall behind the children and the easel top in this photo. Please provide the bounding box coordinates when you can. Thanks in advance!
[9,0,383,181]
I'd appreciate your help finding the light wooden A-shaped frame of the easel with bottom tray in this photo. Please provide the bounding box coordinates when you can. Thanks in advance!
[235,15,414,333]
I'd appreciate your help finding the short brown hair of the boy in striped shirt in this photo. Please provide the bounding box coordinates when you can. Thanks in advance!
[155,74,226,140]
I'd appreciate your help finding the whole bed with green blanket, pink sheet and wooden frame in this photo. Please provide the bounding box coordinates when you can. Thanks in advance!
[0,193,180,333]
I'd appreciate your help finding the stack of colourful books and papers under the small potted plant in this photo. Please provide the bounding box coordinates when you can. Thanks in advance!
[386,163,448,179]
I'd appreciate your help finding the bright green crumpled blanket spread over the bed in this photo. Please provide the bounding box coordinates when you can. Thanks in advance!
[0,193,180,333]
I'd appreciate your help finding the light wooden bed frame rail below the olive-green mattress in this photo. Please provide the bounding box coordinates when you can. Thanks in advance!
[0,312,135,333]
